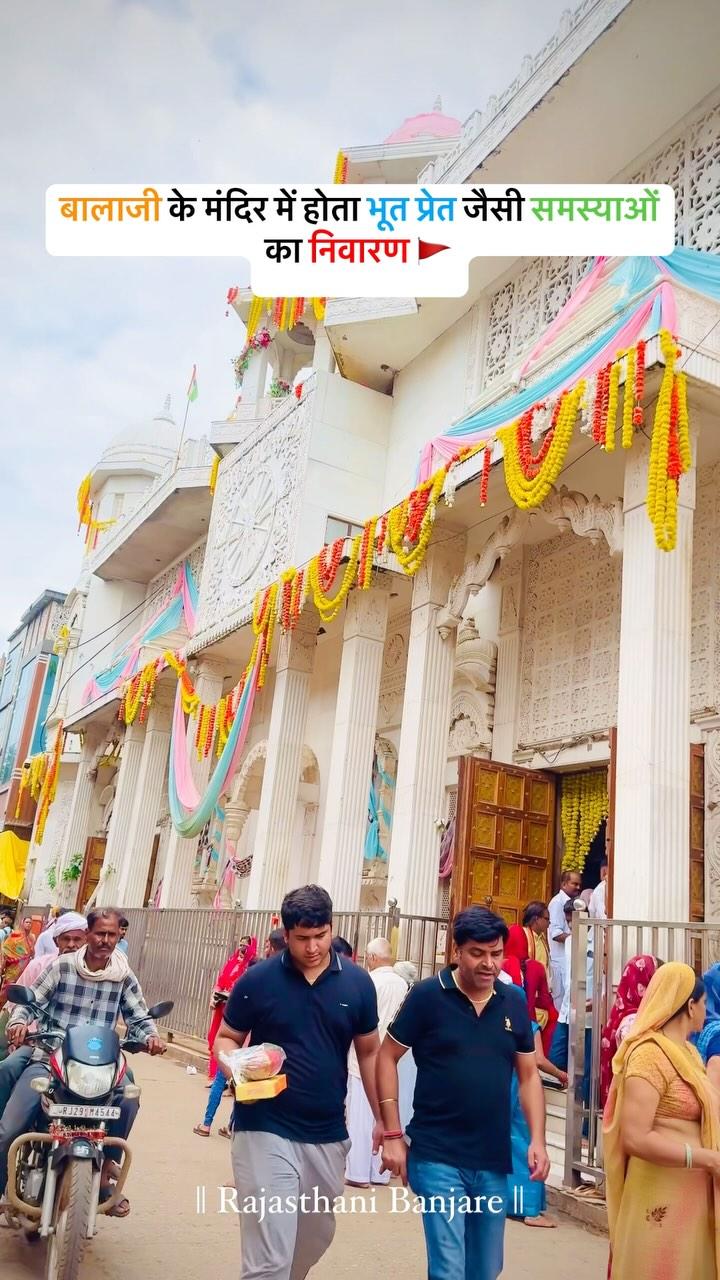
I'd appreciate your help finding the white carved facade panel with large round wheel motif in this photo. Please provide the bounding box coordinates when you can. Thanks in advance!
[197,394,314,643]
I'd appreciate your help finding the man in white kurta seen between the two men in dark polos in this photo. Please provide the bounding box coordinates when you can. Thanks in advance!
[345,938,407,1187]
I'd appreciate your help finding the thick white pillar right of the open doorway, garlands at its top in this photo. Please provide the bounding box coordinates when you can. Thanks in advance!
[612,438,694,920]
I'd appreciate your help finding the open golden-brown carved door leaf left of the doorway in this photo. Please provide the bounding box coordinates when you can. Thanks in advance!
[450,756,556,924]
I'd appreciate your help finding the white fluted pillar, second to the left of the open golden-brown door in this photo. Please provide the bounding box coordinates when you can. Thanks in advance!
[318,585,389,911]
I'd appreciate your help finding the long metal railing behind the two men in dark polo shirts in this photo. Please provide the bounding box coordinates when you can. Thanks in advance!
[117,908,447,1039]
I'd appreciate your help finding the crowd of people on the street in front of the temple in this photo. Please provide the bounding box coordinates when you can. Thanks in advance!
[7,868,720,1280]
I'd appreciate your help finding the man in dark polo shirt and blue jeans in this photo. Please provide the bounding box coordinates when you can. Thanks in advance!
[378,906,550,1280]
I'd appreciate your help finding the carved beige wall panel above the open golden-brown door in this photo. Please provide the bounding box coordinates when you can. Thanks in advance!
[518,532,621,746]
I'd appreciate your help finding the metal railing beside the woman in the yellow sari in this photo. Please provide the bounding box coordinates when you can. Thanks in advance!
[565,910,720,1187]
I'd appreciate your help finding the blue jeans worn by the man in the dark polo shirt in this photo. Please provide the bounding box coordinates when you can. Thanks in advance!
[407,1148,507,1280]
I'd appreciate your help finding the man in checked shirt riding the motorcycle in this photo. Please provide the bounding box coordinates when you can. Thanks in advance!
[0,908,167,1217]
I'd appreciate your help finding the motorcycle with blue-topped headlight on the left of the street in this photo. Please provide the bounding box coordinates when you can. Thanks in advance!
[6,986,173,1280]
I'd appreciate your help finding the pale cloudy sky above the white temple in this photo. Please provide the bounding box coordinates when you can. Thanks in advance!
[0,0,568,648]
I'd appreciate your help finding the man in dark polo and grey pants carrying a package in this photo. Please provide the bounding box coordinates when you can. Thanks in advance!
[215,884,382,1280]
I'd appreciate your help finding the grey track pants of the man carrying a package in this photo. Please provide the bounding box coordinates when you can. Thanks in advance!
[232,1132,350,1280]
